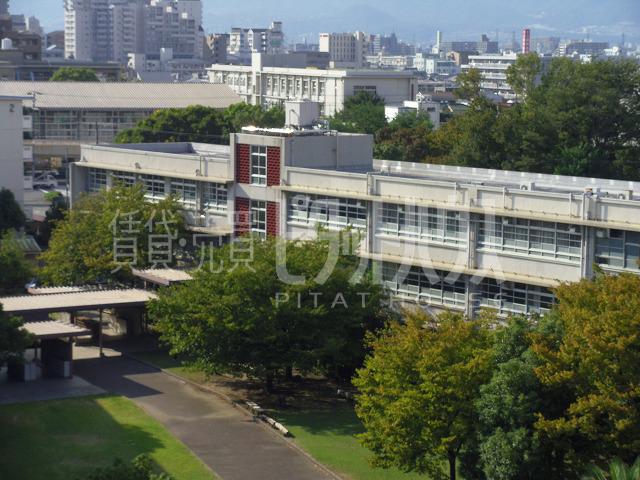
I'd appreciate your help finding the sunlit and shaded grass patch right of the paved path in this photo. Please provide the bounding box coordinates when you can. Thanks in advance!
[277,406,425,480]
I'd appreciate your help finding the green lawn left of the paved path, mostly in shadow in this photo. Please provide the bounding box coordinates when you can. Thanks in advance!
[0,396,215,480]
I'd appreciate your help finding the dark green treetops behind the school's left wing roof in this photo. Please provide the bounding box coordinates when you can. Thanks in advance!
[115,103,285,144]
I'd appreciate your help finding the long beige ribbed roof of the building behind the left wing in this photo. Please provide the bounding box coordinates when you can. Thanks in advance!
[0,82,242,110]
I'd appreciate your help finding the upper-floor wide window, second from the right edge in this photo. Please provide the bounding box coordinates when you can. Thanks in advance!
[478,215,582,263]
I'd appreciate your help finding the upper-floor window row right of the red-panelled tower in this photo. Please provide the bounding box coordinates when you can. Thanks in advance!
[288,195,640,270]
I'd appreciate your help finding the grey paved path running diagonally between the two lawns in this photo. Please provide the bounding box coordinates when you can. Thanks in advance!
[75,357,335,480]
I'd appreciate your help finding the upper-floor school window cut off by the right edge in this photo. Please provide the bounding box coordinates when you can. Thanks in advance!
[596,229,640,271]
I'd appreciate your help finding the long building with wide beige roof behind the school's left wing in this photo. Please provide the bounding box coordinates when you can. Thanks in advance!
[0,82,241,175]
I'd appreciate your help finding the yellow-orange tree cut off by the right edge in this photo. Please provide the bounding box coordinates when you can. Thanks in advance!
[532,274,640,466]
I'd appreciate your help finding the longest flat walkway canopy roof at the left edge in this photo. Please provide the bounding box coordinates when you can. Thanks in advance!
[0,289,157,315]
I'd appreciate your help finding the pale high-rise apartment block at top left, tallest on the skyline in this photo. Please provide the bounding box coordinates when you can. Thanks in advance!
[64,0,204,63]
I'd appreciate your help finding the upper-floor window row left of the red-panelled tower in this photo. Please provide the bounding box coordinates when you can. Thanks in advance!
[88,168,228,213]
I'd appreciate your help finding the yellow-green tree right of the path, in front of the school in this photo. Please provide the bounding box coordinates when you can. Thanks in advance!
[353,311,493,480]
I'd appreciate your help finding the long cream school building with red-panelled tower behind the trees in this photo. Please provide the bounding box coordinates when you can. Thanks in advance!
[71,123,640,315]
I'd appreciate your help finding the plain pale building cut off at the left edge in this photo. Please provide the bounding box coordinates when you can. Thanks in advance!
[0,95,31,205]
